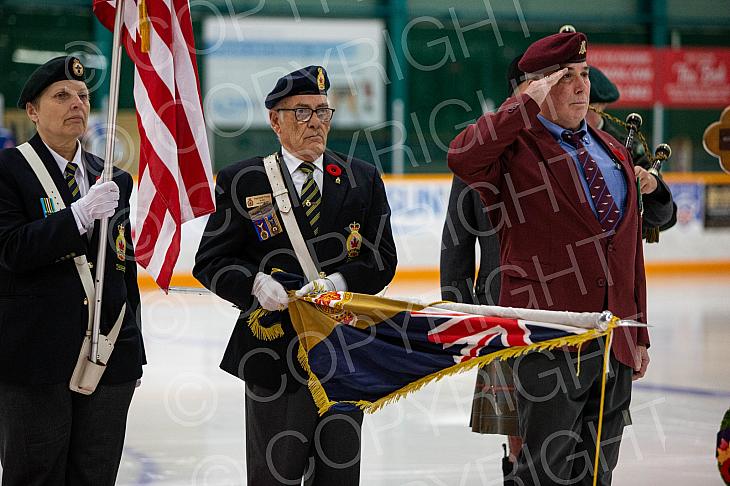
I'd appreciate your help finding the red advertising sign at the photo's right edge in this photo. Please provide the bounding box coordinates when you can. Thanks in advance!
[656,48,730,108]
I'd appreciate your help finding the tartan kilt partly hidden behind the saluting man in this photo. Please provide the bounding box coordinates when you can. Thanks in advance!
[469,360,520,436]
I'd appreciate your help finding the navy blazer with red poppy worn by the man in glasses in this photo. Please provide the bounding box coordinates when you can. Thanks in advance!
[193,151,397,391]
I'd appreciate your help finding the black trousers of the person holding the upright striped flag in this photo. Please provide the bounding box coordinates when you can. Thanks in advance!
[0,381,136,486]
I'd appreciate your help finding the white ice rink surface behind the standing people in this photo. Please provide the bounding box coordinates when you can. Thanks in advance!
[8,277,730,486]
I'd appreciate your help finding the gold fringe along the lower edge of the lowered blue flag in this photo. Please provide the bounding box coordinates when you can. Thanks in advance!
[298,316,620,415]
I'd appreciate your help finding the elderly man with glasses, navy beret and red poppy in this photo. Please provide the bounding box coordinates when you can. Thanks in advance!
[193,66,396,486]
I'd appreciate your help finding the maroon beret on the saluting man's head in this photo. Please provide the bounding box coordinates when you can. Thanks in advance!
[519,32,586,73]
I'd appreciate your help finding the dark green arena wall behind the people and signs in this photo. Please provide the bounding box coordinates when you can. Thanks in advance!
[0,0,730,172]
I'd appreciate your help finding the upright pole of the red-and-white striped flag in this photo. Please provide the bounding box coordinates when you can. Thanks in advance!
[89,0,124,363]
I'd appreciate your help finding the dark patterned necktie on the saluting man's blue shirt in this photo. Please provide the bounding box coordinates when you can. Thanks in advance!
[561,130,621,232]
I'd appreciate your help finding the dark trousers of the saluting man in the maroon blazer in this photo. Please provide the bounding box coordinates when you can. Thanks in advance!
[508,339,632,486]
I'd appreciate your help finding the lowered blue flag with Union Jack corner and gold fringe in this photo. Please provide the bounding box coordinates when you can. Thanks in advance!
[289,292,634,413]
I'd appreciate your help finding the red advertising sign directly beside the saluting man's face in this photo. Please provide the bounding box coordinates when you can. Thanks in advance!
[588,44,657,108]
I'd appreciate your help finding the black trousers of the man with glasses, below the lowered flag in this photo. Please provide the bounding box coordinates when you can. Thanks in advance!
[246,382,363,486]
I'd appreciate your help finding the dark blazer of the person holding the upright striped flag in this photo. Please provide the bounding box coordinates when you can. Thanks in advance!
[0,134,145,384]
